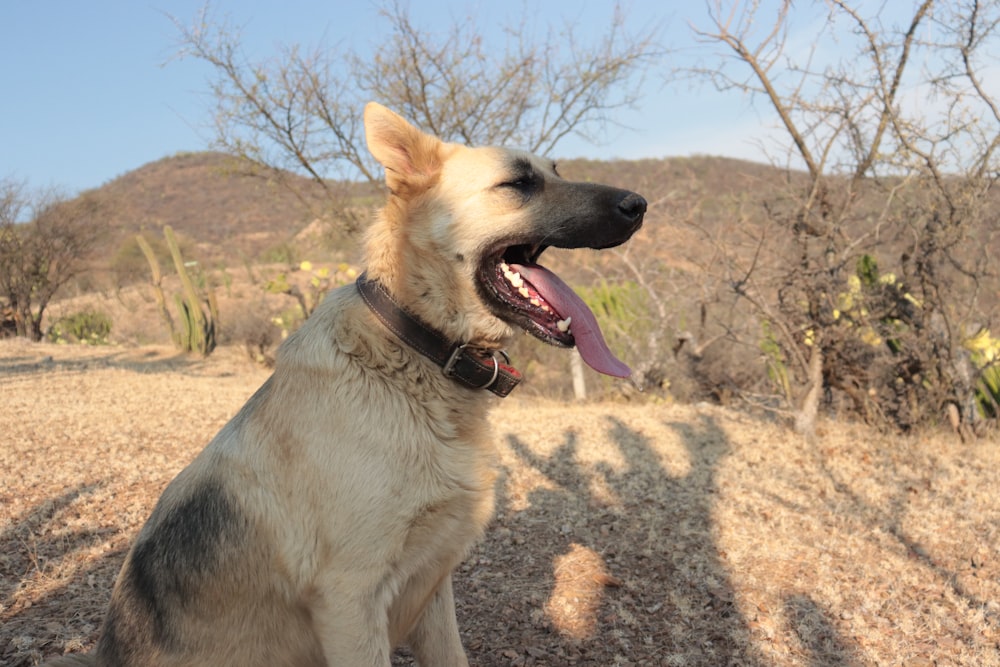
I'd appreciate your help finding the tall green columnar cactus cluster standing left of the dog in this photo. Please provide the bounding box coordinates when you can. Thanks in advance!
[136,225,219,357]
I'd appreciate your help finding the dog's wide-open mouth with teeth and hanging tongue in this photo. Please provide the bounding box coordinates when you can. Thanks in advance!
[479,244,632,377]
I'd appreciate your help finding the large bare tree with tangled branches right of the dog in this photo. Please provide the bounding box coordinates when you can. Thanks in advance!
[690,0,1000,432]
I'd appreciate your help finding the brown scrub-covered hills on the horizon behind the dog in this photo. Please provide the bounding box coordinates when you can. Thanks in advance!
[64,147,1000,286]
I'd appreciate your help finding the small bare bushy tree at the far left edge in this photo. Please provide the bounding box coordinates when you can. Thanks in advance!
[0,179,100,340]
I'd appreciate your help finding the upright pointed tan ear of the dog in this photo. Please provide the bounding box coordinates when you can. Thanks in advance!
[365,102,441,197]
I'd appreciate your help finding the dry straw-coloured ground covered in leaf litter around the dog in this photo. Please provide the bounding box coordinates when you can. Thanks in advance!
[0,341,1000,667]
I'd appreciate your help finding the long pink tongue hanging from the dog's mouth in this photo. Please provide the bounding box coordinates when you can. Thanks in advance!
[510,264,632,378]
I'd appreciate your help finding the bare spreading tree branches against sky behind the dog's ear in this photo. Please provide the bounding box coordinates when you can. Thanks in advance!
[173,2,660,223]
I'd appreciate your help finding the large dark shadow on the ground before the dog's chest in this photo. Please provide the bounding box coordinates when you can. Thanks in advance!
[438,415,764,667]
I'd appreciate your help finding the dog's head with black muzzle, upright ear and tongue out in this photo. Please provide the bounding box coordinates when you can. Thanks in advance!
[365,103,646,377]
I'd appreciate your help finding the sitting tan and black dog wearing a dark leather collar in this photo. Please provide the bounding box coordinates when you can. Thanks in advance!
[43,103,646,667]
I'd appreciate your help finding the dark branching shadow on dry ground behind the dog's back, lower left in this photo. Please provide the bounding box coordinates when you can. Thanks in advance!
[0,484,126,667]
